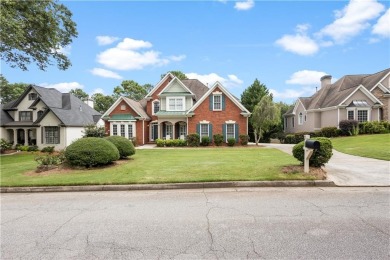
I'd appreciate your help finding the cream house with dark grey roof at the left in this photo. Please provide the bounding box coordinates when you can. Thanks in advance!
[0,85,102,150]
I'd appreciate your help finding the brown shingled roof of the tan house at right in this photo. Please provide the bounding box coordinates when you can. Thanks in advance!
[299,68,390,110]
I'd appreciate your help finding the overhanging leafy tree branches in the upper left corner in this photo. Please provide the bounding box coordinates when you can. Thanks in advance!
[0,0,78,70]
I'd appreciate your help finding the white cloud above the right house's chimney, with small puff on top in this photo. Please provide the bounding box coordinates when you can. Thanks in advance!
[276,24,319,55]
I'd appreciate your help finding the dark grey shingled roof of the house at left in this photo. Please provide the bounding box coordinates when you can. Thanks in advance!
[1,85,101,126]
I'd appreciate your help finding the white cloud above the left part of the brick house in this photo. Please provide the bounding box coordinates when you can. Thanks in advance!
[96,38,186,70]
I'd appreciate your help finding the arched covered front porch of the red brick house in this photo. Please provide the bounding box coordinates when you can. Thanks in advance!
[149,118,188,142]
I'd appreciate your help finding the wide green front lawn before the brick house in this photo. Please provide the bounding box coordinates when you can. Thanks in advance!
[1,148,314,186]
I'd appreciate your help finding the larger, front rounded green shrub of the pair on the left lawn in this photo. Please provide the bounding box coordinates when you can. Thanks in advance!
[65,137,119,168]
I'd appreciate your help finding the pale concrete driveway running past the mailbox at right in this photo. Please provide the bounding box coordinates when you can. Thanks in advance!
[261,144,390,186]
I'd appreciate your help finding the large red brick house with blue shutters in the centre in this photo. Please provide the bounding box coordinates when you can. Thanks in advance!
[102,73,251,145]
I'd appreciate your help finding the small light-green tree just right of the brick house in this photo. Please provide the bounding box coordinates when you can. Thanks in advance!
[252,95,280,145]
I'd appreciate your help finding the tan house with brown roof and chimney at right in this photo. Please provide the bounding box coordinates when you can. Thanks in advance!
[284,69,390,133]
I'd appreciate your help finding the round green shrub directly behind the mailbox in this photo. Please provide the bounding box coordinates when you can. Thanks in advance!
[293,137,333,167]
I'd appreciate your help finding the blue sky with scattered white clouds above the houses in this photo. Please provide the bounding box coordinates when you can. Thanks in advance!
[1,0,390,104]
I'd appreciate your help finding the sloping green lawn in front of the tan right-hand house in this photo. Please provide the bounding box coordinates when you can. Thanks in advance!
[332,134,390,161]
